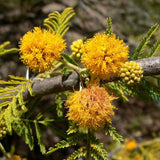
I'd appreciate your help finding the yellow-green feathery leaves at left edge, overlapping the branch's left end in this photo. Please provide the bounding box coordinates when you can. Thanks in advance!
[0,76,32,134]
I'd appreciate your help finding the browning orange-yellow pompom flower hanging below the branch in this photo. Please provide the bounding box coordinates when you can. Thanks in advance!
[66,86,116,130]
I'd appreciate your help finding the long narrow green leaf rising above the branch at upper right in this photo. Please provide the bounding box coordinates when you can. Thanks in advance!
[131,24,159,60]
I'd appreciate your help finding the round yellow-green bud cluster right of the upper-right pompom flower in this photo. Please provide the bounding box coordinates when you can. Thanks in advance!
[120,61,143,85]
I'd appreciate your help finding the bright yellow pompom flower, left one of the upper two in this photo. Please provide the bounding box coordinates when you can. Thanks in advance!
[20,27,66,72]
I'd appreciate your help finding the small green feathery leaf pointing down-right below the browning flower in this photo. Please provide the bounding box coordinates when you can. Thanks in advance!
[104,124,123,143]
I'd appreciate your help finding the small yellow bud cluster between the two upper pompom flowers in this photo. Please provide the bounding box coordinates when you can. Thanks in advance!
[71,39,84,59]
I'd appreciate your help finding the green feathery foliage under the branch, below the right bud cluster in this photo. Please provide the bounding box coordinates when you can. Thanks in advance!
[106,77,160,102]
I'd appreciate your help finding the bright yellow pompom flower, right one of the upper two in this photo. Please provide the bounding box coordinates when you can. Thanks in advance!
[81,33,129,79]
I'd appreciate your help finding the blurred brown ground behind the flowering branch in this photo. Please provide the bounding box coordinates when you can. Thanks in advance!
[0,0,160,160]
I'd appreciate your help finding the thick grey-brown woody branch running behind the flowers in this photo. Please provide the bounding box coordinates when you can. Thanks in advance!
[1,57,160,100]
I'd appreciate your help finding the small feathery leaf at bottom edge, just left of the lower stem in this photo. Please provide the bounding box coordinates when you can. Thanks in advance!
[67,147,87,160]
